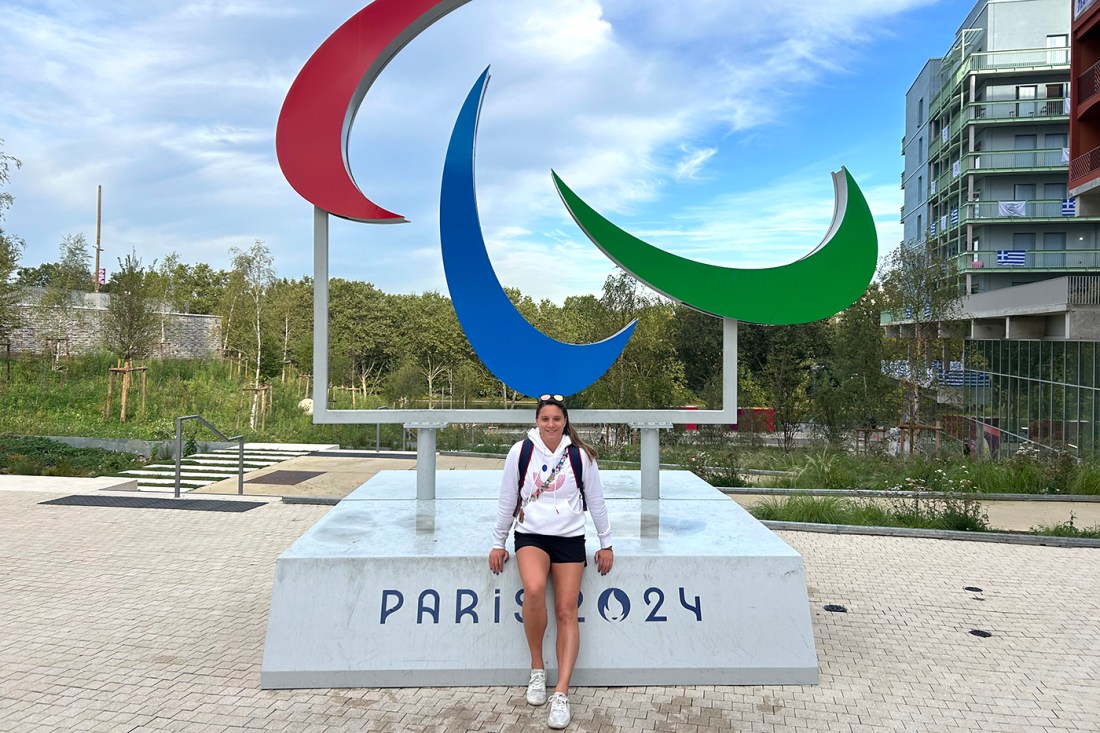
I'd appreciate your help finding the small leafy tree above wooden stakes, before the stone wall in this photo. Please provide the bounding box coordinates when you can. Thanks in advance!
[105,253,160,362]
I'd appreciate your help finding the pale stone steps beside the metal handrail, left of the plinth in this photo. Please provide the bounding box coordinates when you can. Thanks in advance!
[118,442,338,491]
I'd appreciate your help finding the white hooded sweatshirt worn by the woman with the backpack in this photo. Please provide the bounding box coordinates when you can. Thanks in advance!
[493,427,612,548]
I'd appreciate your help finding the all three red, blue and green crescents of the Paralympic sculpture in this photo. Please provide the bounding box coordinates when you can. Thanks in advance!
[276,0,878,395]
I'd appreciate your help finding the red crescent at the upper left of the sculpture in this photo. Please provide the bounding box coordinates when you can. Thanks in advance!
[275,0,470,223]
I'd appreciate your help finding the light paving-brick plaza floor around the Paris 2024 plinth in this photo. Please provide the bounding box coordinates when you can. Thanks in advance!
[0,490,1100,733]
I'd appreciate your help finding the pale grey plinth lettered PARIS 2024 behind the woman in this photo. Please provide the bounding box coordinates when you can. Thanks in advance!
[261,471,817,689]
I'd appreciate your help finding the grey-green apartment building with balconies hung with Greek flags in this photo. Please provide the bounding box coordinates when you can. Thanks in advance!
[888,0,1100,455]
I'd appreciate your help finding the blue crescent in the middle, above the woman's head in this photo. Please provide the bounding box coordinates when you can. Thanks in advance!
[439,68,637,396]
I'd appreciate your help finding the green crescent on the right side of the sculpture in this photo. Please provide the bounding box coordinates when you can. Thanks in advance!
[552,167,879,326]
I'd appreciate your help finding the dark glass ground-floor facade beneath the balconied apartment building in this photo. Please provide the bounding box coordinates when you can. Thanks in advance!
[966,340,1100,457]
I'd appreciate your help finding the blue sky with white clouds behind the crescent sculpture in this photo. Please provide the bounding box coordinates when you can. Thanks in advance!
[0,0,974,303]
